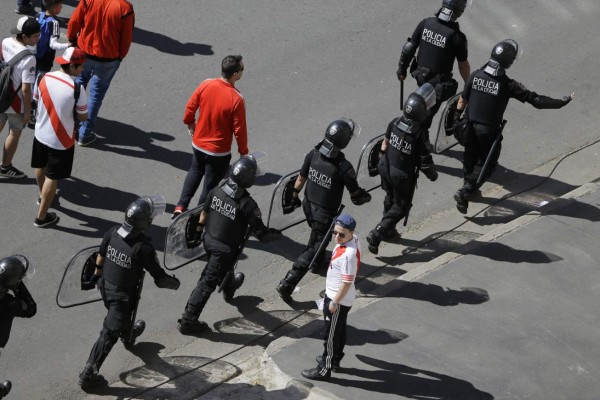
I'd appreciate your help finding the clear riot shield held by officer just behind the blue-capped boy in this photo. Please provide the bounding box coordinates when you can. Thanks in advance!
[267,170,306,231]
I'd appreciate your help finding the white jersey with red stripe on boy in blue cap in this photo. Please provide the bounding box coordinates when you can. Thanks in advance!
[325,235,360,307]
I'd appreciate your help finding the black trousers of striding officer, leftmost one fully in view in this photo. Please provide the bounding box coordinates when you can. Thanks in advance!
[87,279,135,371]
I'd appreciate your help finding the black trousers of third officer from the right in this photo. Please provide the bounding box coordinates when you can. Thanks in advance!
[377,158,415,236]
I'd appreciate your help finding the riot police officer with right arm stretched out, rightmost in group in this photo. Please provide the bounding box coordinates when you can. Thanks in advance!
[454,39,574,214]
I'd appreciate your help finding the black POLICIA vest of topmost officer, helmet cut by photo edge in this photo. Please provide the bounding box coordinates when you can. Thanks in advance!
[417,17,456,79]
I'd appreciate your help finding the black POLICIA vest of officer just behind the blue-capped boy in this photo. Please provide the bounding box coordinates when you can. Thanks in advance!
[306,149,345,213]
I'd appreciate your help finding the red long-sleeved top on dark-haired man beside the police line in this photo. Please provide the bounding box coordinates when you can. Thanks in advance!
[183,78,248,155]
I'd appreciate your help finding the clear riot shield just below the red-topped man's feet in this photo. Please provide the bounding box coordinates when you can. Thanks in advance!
[163,205,206,271]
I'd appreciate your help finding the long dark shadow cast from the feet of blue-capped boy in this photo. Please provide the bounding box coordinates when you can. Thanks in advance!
[332,354,494,400]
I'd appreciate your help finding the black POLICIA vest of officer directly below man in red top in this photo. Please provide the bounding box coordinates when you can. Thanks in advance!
[205,186,250,248]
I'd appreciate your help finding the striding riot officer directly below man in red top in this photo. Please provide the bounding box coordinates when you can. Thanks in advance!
[177,153,281,335]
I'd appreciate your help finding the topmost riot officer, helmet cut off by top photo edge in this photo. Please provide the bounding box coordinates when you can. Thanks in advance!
[396,0,471,127]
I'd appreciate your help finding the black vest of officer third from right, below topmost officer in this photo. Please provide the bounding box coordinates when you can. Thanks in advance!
[385,119,421,175]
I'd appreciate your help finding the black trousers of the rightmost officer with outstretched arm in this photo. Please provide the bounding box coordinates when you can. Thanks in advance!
[463,122,502,192]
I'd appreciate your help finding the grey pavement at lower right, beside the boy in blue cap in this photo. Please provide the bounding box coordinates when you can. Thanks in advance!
[269,183,600,400]
